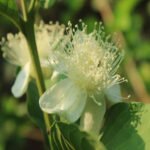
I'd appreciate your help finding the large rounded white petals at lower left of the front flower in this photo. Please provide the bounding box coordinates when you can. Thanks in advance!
[40,78,87,122]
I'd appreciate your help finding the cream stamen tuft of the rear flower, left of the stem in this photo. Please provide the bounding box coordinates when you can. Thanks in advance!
[2,32,30,66]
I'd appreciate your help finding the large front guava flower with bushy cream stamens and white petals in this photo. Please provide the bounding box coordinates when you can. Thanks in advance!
[40,25,124,134]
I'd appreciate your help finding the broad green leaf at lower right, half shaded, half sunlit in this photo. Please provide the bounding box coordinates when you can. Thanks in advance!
[101,102,150,150]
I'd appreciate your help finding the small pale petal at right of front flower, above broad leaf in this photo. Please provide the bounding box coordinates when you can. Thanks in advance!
[105,84,122,104]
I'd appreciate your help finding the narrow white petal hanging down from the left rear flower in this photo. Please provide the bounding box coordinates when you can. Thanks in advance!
[11,63,30,98]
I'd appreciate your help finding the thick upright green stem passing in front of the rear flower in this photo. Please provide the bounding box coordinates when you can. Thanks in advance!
[21,0,51,146]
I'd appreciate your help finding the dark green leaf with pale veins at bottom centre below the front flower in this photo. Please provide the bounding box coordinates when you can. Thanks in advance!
[50,122,105,150]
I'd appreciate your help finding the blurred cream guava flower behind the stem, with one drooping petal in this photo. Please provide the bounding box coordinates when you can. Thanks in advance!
[0,22,64,97]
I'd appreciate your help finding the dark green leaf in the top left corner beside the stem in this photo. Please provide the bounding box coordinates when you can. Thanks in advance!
[0,0,20,29]
